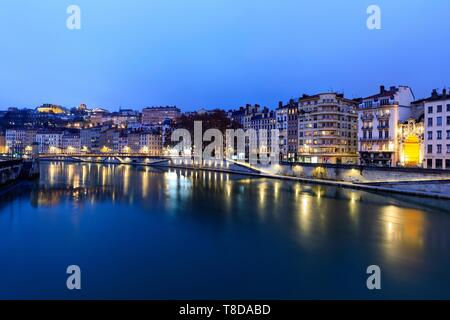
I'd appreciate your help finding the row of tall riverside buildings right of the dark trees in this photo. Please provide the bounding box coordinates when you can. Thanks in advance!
[229,86,450,169]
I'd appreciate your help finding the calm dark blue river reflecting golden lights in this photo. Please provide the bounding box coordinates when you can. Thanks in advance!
[0,162,450,299]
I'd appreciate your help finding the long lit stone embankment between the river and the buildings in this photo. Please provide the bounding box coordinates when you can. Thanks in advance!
[37,156,450,199]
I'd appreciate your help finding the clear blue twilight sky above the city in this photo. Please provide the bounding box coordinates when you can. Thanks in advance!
[0,0,450,110]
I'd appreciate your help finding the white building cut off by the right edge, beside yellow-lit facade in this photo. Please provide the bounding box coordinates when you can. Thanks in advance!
[422,89,450,170]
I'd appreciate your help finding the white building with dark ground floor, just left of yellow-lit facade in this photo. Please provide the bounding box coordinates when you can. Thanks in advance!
[358,86,415,166]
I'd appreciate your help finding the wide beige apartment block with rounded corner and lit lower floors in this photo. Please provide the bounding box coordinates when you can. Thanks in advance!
[298,93,358,164]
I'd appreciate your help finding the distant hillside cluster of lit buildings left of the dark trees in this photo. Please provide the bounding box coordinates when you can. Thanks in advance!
[0,104,181,156]
